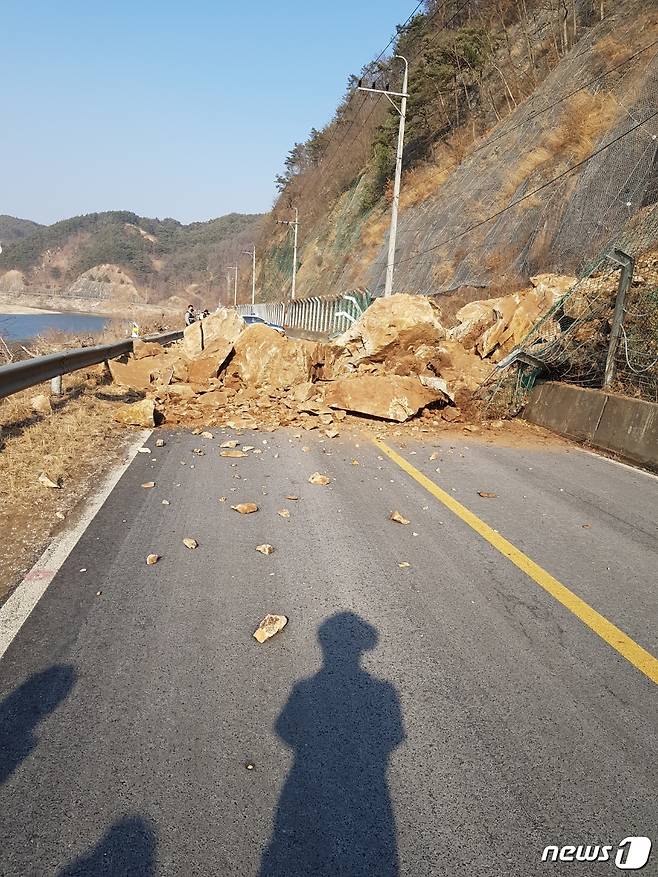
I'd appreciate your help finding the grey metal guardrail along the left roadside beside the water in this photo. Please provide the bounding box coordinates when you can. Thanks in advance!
[0,332,183,399]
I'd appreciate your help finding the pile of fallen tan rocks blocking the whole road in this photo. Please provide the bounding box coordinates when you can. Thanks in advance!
[109,275,584,438]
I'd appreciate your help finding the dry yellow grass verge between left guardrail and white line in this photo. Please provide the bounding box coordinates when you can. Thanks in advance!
[0,366,130,602]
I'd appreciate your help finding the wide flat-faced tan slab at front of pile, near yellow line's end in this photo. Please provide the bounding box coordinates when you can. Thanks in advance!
[324,375,448,423]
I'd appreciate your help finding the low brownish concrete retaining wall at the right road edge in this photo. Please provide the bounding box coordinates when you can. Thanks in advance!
[523,381,658,471]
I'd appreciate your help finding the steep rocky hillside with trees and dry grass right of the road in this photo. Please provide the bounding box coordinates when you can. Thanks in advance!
[254,0,658,299]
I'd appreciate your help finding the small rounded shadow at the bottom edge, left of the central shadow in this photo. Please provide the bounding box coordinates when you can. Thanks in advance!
[57,816,157,877]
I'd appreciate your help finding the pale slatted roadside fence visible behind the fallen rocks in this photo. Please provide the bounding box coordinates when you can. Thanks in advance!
[235,290,372,335]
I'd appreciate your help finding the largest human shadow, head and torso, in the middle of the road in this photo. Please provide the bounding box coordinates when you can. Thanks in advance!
[260,612,404,877]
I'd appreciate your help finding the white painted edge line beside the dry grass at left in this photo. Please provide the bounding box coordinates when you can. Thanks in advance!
[0,429,153,660]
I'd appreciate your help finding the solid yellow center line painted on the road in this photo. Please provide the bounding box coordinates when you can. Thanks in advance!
[375,439,658,684]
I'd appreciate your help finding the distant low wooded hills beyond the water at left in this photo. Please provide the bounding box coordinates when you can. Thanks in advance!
[0,211,261,310]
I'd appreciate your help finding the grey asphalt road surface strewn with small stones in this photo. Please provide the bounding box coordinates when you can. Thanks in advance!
[0,431,658,877]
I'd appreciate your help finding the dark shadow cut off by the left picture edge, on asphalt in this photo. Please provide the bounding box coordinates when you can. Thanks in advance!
[0,664,76,785]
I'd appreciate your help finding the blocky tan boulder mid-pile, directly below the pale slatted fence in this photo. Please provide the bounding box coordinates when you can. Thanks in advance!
[227,323,321,389]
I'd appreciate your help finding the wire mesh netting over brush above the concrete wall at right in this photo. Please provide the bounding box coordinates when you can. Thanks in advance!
[480,205,658,415]
